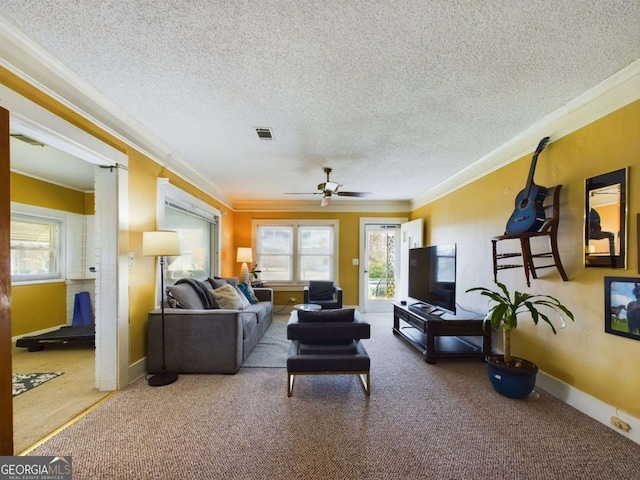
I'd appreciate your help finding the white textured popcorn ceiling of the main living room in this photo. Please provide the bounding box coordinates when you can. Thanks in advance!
[0,0,640,208]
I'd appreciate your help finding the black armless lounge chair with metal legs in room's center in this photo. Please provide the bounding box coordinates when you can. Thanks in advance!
[287,309,371,397]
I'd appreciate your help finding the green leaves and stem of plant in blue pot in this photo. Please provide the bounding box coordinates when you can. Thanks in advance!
[467,282,573,365]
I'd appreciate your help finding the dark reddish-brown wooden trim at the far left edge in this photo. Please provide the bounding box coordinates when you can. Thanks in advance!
[0,107,13,456]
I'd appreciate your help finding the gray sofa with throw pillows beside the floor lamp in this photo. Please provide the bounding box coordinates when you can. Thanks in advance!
[147,279,273,373]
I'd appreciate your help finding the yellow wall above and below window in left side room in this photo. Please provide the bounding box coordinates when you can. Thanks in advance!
[11,172,93,336]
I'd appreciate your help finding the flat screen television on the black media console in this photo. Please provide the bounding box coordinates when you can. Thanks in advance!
[409,243,456,314]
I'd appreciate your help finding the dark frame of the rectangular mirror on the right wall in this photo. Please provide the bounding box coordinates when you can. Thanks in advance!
[584,168,628,268]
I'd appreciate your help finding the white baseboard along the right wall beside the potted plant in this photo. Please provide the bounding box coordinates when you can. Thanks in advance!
[536,371,640,444]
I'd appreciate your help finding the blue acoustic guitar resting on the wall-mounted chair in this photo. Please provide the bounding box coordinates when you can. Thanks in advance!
[506,137,549,235]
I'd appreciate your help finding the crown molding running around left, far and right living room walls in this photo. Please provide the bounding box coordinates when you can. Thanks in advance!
[0,16,640,212]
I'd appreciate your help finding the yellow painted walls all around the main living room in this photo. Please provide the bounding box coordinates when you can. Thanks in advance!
[5,67,640,417]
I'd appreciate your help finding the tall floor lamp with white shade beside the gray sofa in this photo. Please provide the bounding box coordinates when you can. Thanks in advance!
[142,230,180,387]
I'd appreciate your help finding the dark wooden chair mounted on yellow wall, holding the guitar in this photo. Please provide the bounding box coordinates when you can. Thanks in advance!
[491,185,569,287]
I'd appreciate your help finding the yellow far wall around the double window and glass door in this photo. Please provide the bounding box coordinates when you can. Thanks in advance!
[233,212,409,305]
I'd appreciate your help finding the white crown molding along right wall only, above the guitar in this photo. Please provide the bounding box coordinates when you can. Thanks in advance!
[411,59,640,210]
